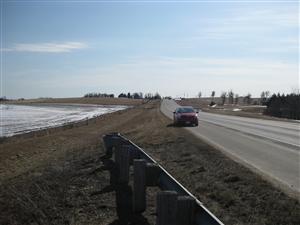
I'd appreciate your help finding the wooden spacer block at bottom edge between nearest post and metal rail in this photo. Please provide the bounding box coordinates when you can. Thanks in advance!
[176,196,196,225]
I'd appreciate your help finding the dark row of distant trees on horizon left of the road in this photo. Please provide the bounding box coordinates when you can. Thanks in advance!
[83,92,161,99]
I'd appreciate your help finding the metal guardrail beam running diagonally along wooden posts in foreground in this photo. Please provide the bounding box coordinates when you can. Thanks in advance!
[103,133,224,225]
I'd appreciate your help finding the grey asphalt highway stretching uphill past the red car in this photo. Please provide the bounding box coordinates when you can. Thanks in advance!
[161,100,300,193]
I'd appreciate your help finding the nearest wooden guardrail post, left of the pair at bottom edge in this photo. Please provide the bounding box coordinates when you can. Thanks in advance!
[156,191,178,225]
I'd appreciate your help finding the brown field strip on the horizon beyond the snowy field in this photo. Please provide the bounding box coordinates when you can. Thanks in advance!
[2,98,144,105]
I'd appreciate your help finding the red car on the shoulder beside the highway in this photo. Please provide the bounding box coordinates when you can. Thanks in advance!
[173,106,198,126]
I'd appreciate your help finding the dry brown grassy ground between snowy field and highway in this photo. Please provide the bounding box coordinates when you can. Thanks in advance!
[0,101,300,225]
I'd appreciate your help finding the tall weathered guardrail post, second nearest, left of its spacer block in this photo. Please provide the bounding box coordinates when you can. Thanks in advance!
[133,159,146,213]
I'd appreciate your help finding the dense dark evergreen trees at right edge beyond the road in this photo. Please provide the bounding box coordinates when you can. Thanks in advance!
[265,94,300,120]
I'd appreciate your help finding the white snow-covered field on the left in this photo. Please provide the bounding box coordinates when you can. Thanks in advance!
[0,104,128,137]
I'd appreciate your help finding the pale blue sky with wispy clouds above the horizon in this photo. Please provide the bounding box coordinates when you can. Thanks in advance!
[0,0,300,98]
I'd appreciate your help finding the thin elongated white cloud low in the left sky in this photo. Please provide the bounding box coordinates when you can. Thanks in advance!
[1,42,88,53]
